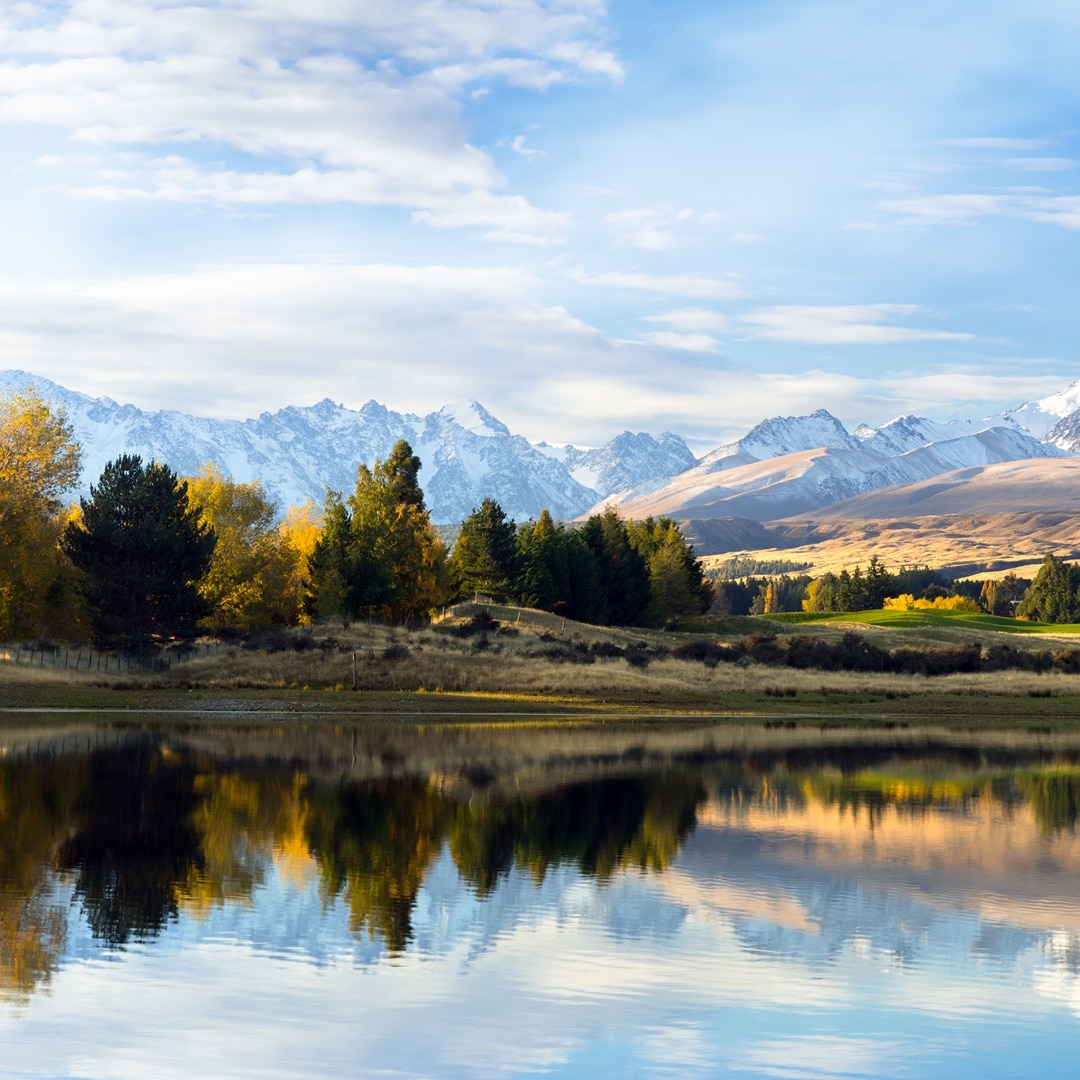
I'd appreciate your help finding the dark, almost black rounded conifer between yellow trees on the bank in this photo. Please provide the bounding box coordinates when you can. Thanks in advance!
[62,455,216,649]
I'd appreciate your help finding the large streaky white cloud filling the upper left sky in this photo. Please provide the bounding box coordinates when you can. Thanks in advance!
[0,0,621,240]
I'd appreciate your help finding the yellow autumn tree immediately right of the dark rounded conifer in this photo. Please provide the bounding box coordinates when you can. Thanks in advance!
[188,464,300,631]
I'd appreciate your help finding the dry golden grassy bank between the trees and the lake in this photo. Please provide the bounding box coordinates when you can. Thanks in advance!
[6,606,1080,725]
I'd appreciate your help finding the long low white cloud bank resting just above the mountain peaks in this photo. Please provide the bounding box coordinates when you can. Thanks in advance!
[0,267,1066,453]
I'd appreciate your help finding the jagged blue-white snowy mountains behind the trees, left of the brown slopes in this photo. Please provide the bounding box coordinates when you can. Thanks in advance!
[0,372,696,524]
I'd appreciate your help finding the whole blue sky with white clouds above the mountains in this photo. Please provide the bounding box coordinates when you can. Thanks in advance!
[0,0,1080,453]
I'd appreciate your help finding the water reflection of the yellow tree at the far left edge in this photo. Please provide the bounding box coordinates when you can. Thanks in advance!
[0,761,81,997]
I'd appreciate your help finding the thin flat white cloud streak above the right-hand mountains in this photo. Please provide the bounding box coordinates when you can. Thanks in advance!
[738,303,973,345]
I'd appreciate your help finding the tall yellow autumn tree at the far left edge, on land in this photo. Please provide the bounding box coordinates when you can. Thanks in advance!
[0,389,81,637]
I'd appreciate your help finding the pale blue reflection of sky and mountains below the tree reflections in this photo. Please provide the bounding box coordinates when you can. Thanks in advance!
[6,813,1080,1078]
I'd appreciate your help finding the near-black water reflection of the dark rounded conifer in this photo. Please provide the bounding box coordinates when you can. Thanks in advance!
[57,744,201,945]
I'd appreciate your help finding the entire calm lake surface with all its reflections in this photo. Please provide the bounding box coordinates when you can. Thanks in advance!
[0,717,1080,1078]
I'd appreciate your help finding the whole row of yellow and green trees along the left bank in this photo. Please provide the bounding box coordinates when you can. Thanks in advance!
[0,391,712,651]
